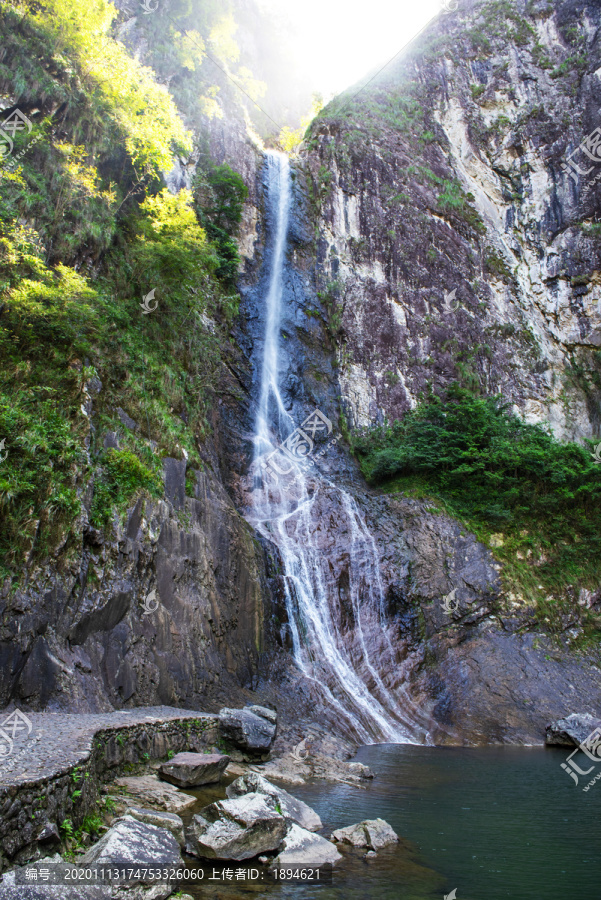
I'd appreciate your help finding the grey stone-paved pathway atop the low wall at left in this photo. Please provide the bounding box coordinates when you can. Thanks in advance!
[0,706,218,787]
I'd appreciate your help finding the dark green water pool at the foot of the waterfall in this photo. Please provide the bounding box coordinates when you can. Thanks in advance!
[188,744,601,900]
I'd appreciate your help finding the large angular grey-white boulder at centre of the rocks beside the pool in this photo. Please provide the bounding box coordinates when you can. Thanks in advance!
[186,793,288,860]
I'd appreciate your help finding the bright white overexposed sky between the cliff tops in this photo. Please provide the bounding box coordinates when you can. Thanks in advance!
[260,0,441,97]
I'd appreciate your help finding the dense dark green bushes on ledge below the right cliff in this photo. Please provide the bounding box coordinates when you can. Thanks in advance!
[354,386,601,620]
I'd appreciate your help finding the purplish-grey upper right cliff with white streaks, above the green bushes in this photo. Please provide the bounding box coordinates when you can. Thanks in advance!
[303,0,601,439]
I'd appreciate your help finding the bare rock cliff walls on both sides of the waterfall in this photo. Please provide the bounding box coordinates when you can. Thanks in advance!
[0,0,601,742]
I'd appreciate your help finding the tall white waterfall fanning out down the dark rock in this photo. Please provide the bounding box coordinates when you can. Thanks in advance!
[248,151,427,743]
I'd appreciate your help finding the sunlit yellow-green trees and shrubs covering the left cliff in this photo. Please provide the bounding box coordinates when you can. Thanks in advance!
[0,0,246,578]
